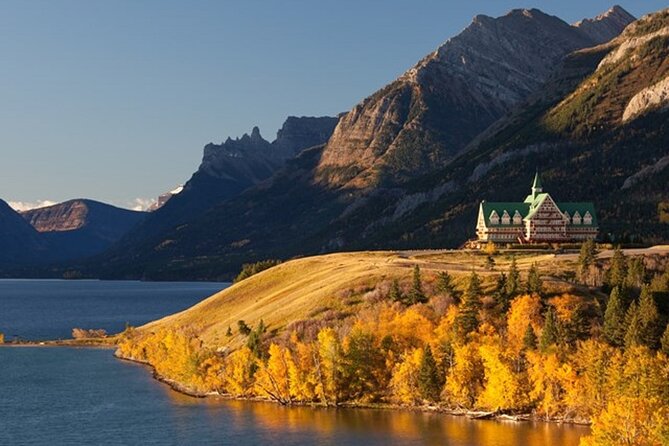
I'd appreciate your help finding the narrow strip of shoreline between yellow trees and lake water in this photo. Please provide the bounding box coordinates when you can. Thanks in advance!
[114,353,592,427]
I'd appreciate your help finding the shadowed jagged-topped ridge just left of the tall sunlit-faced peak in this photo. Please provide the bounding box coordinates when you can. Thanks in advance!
[112,116,339,251]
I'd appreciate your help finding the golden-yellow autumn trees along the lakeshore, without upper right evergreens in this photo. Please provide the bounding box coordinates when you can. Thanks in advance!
[118,254,669,445]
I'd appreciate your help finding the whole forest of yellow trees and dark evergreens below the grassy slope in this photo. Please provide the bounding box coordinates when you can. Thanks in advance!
[117,242,669,445]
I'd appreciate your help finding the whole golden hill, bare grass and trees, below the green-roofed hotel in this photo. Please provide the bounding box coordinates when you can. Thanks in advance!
[115,244,669,444]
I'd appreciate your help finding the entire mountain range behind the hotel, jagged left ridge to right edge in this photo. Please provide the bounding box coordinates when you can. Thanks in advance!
[5,6,669,279]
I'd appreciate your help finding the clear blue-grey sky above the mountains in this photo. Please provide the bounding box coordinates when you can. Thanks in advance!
[0,0,667,208]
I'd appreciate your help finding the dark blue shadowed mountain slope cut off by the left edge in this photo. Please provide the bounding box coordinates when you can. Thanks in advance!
[0,200,49,266]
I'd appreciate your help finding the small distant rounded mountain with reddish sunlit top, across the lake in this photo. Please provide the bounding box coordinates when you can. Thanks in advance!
[21,199,146,260]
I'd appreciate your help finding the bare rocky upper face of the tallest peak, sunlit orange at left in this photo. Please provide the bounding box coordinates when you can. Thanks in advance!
[318,7,633,187]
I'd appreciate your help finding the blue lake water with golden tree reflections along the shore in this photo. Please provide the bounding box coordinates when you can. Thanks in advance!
[0,281,588,446]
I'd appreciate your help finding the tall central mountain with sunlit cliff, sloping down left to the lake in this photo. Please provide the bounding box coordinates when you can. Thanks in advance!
[88,8,643,279]
